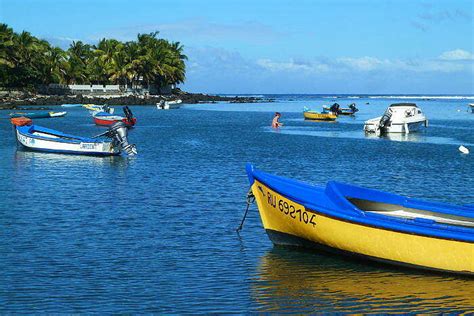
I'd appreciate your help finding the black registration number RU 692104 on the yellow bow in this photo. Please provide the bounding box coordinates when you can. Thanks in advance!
[258,186,316,227]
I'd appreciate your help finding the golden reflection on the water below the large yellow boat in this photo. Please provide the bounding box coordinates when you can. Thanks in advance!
[252,247,474,313]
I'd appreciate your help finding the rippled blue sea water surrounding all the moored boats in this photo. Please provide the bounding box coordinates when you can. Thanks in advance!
[0,96,474,313]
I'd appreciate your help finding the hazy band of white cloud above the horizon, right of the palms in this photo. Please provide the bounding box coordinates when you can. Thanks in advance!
[183,46,474,93]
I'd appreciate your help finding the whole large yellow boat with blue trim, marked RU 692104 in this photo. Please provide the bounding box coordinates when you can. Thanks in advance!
[246,164,474,275]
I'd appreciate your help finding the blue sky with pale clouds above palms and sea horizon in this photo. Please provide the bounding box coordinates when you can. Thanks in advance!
[0,0,474,95]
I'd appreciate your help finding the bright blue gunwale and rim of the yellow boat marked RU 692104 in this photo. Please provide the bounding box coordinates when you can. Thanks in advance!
[246,165,474,242]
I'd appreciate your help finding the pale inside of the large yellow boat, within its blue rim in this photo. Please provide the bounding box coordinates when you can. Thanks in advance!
[347,197,474,227]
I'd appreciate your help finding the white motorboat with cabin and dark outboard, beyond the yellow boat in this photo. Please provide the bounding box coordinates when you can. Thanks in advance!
[364,103,428,134]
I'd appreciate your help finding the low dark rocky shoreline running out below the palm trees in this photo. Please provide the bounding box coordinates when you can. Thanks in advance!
[0,91,273,110]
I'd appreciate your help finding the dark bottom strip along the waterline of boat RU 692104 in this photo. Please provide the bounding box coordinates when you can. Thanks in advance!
[265,229,473,276]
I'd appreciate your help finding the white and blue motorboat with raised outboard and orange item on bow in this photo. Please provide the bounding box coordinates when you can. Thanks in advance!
[11,117,136,156]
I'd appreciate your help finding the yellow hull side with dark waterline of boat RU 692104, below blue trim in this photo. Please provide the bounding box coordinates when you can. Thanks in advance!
[252,180,474,274]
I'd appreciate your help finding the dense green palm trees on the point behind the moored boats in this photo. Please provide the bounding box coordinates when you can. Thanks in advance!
[0,24,187,88]
